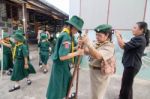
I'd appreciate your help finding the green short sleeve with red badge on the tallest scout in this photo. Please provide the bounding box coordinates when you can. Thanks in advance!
[58,34,71,57]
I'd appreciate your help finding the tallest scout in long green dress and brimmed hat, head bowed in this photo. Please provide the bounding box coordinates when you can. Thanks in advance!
[46,16,84,99]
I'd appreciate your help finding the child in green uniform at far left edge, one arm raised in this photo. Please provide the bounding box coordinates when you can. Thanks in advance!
[0,33,13,75]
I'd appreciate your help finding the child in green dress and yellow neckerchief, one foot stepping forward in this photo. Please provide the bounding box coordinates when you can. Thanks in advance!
[9,33,35,92]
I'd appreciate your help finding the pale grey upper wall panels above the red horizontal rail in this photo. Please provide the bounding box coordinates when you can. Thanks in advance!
[70,0,149,30]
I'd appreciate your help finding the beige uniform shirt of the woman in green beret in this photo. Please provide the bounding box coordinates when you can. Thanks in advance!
[89,41,114,67]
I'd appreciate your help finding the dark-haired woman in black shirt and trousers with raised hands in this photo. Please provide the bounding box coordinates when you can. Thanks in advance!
[116,22,149,99]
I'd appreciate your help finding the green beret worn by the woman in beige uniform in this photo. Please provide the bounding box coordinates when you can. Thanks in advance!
[94,24,112,33]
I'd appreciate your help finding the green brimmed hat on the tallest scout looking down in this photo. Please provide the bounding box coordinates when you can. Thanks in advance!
[66,16,84,33]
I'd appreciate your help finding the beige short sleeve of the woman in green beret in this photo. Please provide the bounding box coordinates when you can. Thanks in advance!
[99,45,115,60]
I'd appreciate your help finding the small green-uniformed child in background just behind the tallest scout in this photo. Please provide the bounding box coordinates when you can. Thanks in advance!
[38,33,50,73]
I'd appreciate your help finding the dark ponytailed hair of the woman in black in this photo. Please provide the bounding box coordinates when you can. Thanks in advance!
[137,22,150,46]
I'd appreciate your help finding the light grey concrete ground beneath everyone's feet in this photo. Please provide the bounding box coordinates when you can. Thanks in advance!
[0,45,150,99]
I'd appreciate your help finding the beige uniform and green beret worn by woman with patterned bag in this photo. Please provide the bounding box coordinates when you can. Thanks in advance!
[89,25,114,99]
